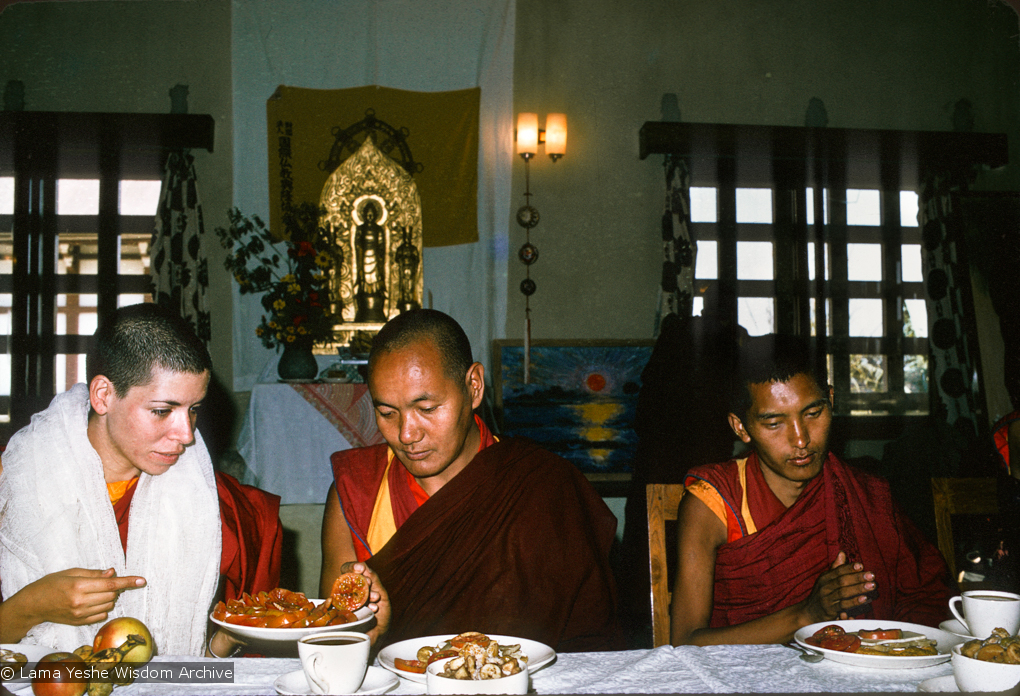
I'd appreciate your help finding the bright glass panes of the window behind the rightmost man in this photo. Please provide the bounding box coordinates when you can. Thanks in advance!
[691,186,928,415]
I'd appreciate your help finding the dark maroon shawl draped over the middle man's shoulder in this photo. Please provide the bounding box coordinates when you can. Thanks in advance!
[336,432,623,652]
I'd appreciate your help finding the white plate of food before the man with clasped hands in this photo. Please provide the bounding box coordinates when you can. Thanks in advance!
[794,618,964,669]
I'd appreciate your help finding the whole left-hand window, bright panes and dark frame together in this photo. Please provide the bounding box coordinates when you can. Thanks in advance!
[0,111,212,443]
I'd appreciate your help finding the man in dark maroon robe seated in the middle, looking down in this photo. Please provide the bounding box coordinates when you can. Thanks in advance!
[319,309,623,652]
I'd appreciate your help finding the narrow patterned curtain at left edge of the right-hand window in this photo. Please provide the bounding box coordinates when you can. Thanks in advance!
[655,155,698,336]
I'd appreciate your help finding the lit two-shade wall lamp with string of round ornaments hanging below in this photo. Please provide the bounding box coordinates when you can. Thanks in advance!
[517,112,567,384]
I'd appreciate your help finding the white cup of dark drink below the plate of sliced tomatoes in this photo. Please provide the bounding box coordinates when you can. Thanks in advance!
[298,631,369,694]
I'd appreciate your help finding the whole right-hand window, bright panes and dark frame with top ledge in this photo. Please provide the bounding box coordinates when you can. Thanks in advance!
[640,121,1008,432]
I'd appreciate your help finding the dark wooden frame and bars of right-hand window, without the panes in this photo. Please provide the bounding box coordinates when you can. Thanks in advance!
[640,121,1008,428]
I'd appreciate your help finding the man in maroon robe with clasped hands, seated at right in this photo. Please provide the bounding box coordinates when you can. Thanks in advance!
[671,336,951,645]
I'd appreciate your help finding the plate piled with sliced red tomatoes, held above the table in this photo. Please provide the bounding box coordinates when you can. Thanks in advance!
[209,573,374,642]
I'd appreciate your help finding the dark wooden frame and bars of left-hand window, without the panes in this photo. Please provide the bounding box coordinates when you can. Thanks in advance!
[0,111,214,443]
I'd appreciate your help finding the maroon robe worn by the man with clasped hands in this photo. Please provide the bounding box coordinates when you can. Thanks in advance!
[691,454,952,628]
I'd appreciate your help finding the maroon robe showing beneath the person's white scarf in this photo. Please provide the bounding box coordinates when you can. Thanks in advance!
[113,471,284,599]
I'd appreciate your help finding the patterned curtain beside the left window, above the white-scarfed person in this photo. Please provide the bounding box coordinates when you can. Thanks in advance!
[149,150,210,344]
